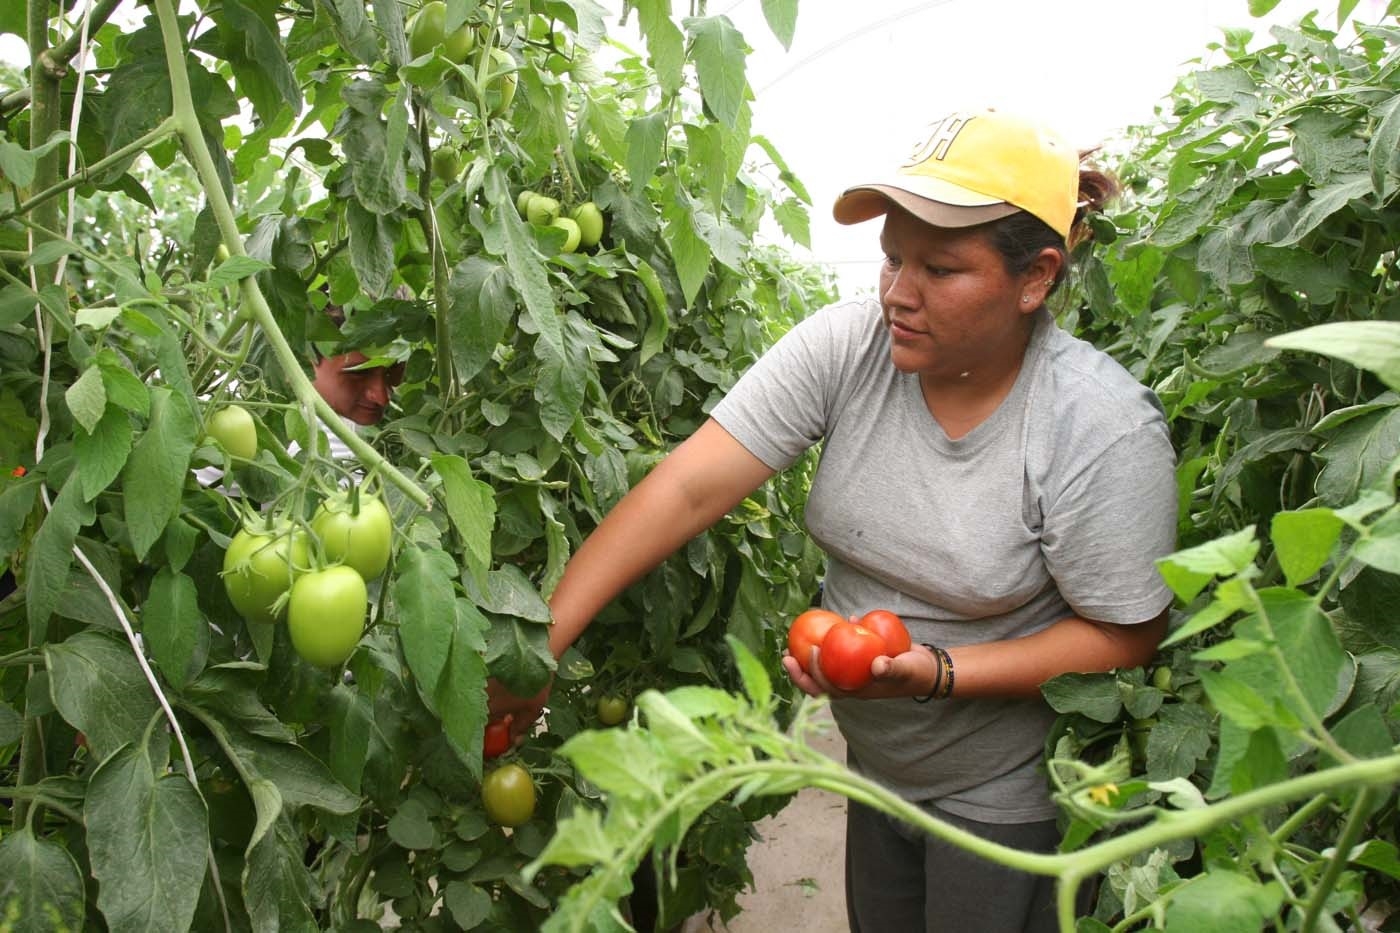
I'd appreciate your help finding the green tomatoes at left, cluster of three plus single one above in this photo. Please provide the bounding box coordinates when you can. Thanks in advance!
[207,405,393,668]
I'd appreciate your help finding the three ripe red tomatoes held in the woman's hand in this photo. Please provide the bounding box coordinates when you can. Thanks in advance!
[788,609,913,691]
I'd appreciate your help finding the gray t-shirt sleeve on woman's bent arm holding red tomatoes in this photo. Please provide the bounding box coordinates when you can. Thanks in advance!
[1040,422,1176,623]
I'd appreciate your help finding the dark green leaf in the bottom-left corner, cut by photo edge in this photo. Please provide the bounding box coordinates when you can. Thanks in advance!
[0,825,87,933]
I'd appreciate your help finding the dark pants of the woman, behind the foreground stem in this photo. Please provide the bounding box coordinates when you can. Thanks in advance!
[846,801,1060,933]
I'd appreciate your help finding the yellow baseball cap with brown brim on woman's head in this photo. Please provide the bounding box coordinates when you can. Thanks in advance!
[832,109,1079,237]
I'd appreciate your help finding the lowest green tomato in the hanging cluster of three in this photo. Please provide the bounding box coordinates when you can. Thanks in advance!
[287,565,370,667]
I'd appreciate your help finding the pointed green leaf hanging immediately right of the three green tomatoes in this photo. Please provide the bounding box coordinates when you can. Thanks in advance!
[393,546,456,702]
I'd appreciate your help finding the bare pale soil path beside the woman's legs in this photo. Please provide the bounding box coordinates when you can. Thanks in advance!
[685,712,850,933]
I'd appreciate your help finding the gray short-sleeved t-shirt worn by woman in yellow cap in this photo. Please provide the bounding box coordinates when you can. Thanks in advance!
[713,300,1176,822]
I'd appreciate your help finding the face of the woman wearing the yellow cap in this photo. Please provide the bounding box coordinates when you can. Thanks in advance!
[879,210,1060,381]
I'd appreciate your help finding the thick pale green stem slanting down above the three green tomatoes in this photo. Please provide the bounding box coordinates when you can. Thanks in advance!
[155,0,433,509]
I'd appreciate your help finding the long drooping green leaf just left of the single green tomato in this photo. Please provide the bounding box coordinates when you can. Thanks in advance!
[122,388,199,558]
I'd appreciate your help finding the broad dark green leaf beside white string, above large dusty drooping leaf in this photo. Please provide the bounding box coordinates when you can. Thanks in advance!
[43,632,160,761]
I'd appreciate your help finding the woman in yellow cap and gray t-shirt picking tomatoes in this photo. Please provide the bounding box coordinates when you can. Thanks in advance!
[496,111,1176,933]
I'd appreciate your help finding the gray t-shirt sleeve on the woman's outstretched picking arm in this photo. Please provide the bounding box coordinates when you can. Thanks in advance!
[710,305,860,469]
